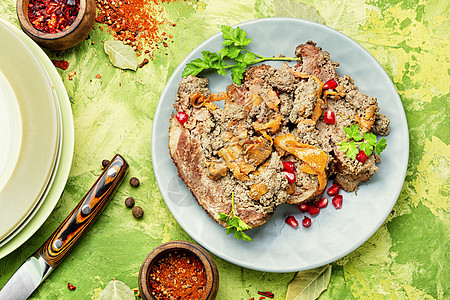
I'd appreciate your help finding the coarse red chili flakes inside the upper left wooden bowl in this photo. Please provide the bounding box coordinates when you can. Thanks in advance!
[28,0,80,33]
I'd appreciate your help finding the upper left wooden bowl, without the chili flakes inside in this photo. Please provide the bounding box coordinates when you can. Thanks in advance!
[16,0,96,50]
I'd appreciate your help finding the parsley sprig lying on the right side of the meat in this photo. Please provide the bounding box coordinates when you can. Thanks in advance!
[337,124,387,159]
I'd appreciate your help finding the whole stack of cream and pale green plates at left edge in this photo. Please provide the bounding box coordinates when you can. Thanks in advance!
[0,19,74,258]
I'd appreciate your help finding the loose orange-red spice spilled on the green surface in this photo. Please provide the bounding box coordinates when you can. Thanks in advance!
[95,0,177,55]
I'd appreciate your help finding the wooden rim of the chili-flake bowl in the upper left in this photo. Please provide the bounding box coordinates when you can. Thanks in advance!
[16,0,89,40]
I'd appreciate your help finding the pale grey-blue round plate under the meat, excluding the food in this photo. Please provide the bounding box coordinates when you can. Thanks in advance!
[152,18,409,272]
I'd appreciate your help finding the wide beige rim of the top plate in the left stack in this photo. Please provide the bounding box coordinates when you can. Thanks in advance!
[0,20,60,241]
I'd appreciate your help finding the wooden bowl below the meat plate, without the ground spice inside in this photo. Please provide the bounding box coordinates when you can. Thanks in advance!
[139,241,219,300]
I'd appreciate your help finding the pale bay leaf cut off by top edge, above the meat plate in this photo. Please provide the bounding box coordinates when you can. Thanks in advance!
[273,0,325,24]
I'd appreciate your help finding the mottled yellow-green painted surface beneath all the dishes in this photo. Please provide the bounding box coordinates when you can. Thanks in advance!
[0,0,450,300]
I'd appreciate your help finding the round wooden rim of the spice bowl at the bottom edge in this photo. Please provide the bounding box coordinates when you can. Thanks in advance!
[139,241,219,300]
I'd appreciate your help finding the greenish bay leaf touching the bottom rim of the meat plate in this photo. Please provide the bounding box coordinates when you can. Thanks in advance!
[286,265,331,300]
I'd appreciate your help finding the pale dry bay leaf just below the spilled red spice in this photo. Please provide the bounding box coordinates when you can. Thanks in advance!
[104,41,138,71]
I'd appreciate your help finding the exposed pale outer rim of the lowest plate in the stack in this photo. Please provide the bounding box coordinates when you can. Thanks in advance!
[0,19,74,258]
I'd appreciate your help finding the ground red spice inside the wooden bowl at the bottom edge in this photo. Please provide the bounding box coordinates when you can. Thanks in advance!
[147,250,206,300]
